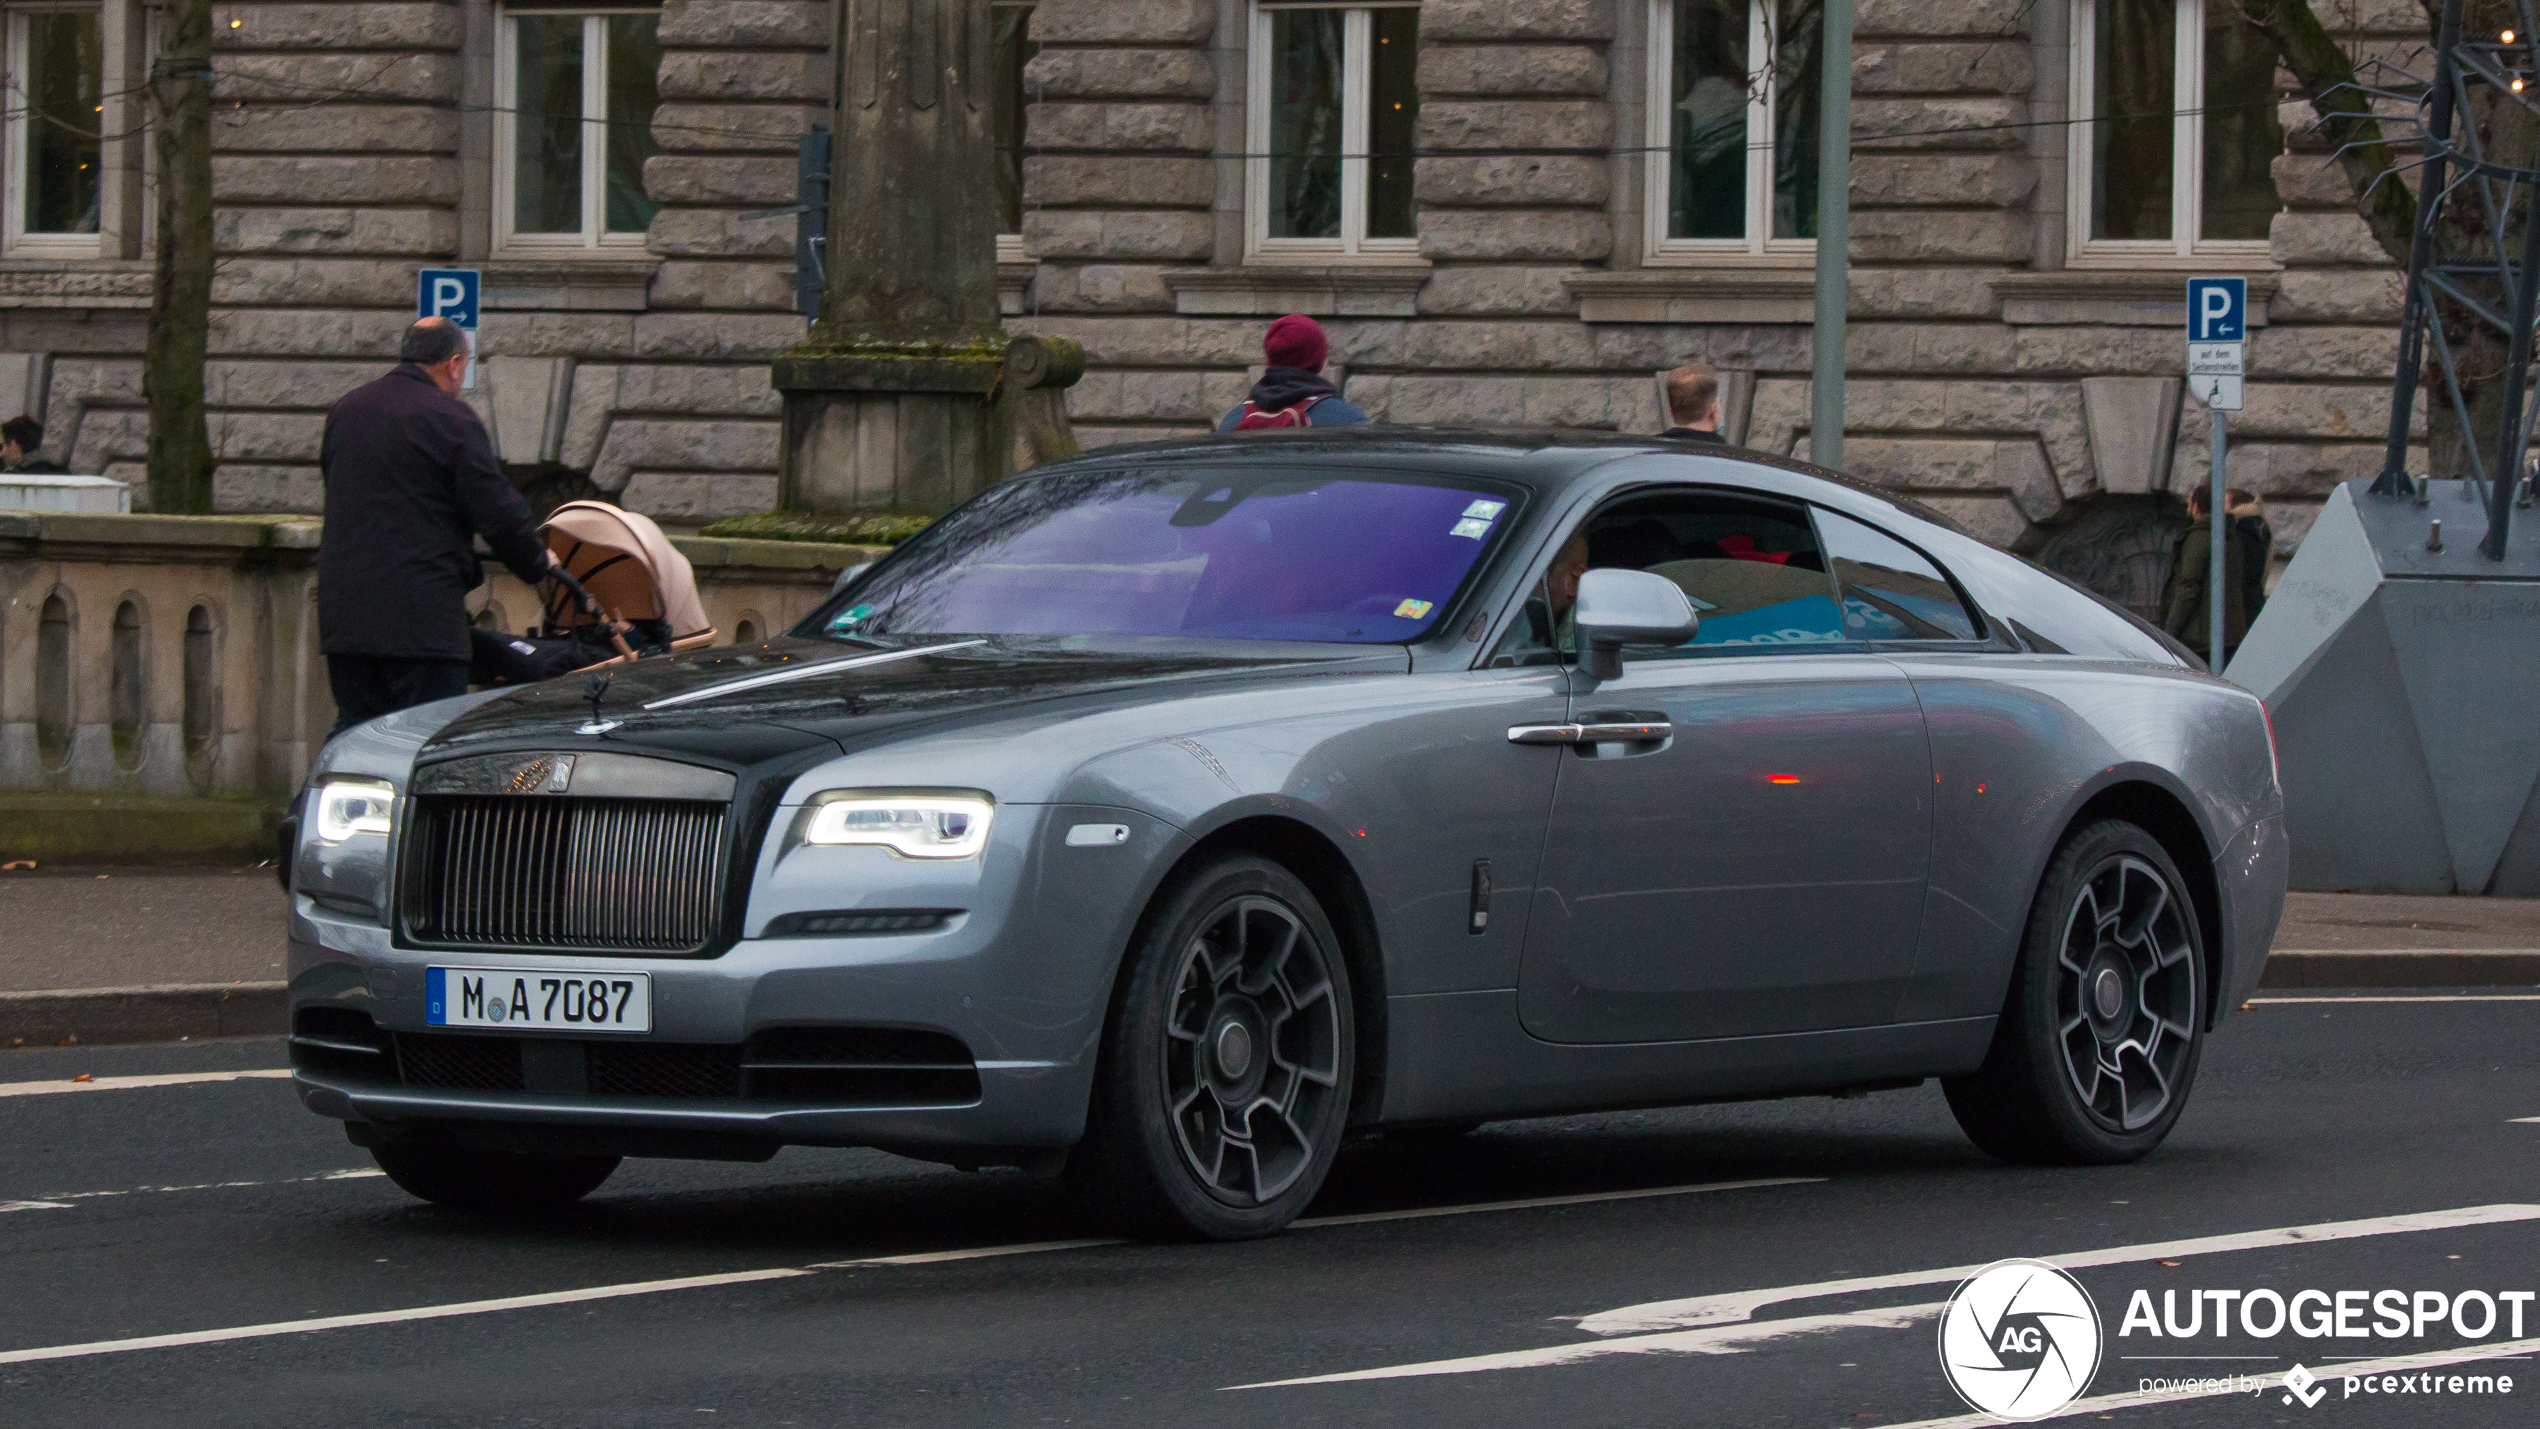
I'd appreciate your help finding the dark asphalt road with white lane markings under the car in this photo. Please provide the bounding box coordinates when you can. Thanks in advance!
[0,990,2540,1429]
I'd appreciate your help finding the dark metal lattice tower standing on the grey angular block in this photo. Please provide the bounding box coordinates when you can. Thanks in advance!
[2357,0,2540,561]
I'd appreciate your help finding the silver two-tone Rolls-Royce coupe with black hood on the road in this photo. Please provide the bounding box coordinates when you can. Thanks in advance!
[290,426,2286,1236]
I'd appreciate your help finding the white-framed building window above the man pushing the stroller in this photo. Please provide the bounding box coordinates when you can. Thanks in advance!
[493,8,660,249]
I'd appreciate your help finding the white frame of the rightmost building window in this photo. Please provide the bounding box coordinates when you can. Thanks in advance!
[2065,0,2273,269]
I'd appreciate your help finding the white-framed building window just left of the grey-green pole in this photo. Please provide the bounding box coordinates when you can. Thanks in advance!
[1648,0,1824,259]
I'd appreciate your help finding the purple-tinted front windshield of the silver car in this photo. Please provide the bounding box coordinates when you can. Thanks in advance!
[800,467,1516,645]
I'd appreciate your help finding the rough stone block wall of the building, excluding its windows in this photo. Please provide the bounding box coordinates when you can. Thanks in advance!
[0,0,2423,599]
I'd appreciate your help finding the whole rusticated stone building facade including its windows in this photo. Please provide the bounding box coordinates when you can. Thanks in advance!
[0,0,2423,604]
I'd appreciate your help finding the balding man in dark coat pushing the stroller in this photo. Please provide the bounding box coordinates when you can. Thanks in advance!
[318,317,551,734]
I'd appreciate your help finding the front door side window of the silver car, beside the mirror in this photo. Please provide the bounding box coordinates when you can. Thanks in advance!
[1491,490,1849,665]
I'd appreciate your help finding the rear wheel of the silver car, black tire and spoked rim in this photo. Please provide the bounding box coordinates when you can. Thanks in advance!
[1941,820,2207,1165]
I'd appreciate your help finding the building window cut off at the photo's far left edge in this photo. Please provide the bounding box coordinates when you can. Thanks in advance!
[0,5,107,256]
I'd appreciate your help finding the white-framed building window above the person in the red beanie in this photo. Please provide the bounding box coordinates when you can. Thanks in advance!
[1245,0,1420,256]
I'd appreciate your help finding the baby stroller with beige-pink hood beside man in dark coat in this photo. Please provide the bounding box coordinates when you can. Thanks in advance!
[470,500,714,685]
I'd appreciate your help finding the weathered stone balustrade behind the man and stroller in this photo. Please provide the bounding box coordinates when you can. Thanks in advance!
[0,513,879,860]
